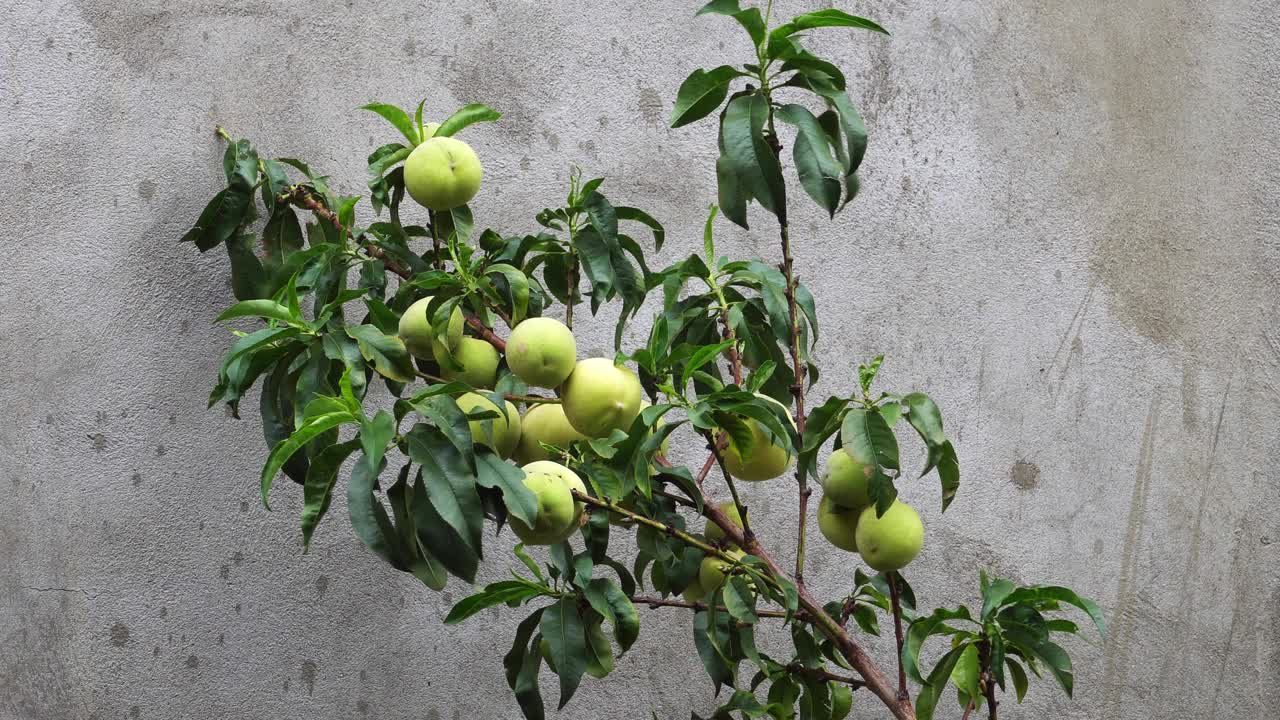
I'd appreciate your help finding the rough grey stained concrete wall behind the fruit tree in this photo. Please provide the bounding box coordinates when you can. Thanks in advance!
[0,0,1280,720]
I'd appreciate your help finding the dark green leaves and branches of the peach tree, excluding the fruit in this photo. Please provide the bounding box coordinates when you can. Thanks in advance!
[182,0,1102,720]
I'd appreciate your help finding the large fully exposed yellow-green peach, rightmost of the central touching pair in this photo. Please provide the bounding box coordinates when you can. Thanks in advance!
[561,357,641,437]
